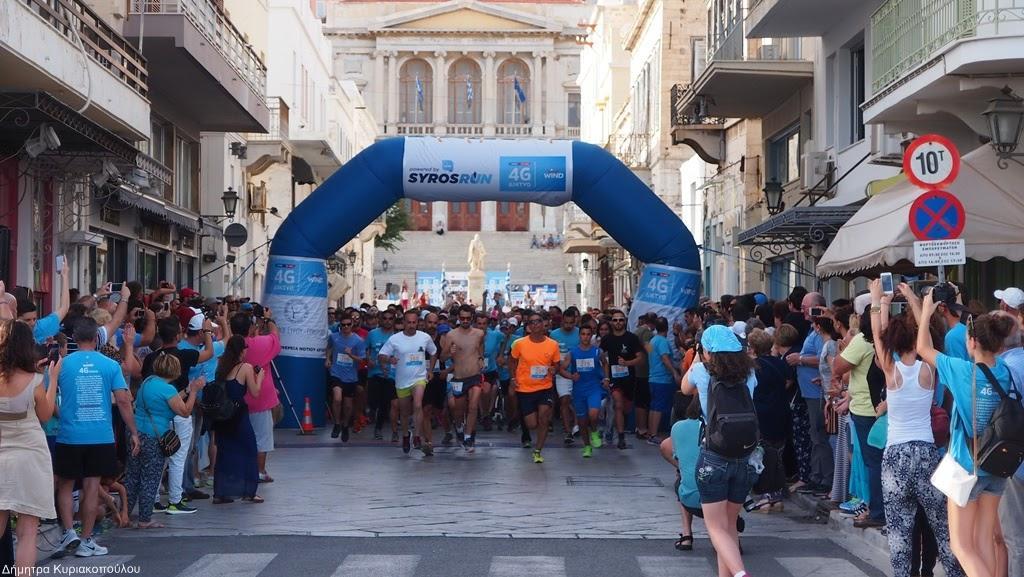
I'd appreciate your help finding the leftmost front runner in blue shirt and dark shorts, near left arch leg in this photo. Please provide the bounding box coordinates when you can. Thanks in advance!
[326,313,367,443]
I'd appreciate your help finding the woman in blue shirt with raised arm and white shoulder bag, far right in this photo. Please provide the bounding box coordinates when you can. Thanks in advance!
[918,293,1015,577]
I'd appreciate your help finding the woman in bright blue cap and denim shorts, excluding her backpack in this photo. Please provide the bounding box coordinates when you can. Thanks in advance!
[681,325,758,577]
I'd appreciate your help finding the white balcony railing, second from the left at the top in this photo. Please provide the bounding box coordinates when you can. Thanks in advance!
[131,0,266,99]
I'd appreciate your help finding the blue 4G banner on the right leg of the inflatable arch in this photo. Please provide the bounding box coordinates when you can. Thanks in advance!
[629,264,700,330]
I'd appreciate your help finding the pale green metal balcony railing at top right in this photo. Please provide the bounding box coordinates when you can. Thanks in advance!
[871,0,1024,94]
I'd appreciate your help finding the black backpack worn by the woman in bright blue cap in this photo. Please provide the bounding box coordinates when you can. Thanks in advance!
[705,376,761,459]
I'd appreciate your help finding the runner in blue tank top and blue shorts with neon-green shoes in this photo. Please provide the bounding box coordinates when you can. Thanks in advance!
[560,325,611,458]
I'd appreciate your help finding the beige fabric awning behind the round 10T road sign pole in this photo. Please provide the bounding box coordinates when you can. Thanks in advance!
[817,145,1024,278]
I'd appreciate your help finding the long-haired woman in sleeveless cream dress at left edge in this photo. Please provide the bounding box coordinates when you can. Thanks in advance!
[0,319,60,574]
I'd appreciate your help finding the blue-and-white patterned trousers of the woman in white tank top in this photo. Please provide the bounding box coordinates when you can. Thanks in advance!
[882,441,965,577]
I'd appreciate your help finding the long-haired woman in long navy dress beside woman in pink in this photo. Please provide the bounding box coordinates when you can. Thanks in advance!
[213,335,266,505]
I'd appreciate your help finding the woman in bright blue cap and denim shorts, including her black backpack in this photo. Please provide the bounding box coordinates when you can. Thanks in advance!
[681,325,760,577]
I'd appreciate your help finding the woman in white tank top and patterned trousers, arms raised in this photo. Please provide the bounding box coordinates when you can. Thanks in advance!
[870,280,965,577]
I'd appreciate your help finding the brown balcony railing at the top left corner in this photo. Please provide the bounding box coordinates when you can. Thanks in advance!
[18,0,150,96]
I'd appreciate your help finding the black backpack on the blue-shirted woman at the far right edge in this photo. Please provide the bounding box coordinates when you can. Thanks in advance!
[976,363,1024,479]
